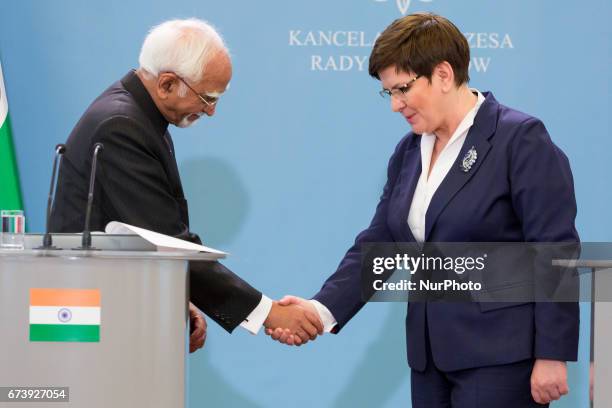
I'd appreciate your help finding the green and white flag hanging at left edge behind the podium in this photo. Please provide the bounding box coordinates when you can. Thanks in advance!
[0,60,23,210]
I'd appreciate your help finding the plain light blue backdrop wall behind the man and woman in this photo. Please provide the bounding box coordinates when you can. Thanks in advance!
[0,0,612,407]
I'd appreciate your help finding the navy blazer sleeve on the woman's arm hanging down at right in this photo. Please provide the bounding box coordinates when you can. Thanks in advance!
[510,118,580,361]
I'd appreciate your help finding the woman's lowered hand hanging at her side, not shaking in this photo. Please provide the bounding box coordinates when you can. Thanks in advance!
[531,359,569,404]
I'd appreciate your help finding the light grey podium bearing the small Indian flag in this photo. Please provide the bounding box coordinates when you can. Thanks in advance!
[0,234,222,408]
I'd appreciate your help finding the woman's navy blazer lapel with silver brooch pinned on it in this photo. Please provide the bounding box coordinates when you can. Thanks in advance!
[425,93,499,241]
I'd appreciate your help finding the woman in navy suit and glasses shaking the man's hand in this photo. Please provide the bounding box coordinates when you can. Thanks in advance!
[273,14,578,408]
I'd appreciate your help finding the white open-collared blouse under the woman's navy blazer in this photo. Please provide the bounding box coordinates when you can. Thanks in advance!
[408,89,485,242]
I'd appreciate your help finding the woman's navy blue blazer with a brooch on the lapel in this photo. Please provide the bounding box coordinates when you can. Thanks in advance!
[314,92,579,371]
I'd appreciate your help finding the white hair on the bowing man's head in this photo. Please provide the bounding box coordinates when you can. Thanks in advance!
[138,18,229,96]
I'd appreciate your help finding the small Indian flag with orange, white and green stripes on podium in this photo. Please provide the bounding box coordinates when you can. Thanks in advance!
[30,288,100,342]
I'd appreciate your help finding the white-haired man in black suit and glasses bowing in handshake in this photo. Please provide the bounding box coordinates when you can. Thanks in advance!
[51,19,322,352]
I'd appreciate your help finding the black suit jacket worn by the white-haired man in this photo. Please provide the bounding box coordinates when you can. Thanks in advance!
[51,71,261,332]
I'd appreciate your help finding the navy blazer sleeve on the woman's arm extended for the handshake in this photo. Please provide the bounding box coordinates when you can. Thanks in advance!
[313,133,414,333]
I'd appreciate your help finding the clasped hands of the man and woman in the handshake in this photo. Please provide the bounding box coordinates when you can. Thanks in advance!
[264,299,323,346]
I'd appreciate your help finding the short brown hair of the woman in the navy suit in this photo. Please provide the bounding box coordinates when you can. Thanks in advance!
[369,13,470,86]
